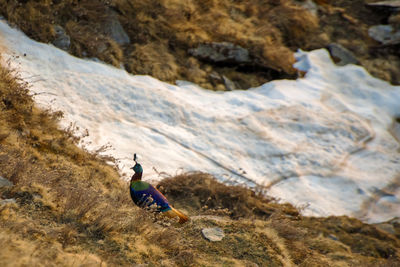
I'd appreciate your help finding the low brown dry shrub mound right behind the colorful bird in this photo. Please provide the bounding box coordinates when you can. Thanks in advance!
[158,173,298,219]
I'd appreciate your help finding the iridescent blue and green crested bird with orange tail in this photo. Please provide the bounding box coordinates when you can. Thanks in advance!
[130,154,189,223]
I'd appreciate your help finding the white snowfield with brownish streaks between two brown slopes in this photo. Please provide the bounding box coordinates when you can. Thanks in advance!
[0,20,400,222]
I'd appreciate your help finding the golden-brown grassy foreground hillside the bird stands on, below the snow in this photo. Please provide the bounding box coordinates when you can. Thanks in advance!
[0,60,400,266]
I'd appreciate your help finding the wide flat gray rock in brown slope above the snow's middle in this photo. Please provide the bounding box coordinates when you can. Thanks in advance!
[189,42,250,64]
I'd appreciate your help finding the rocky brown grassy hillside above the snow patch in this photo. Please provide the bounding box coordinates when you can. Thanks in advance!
[0,0,400,90]
